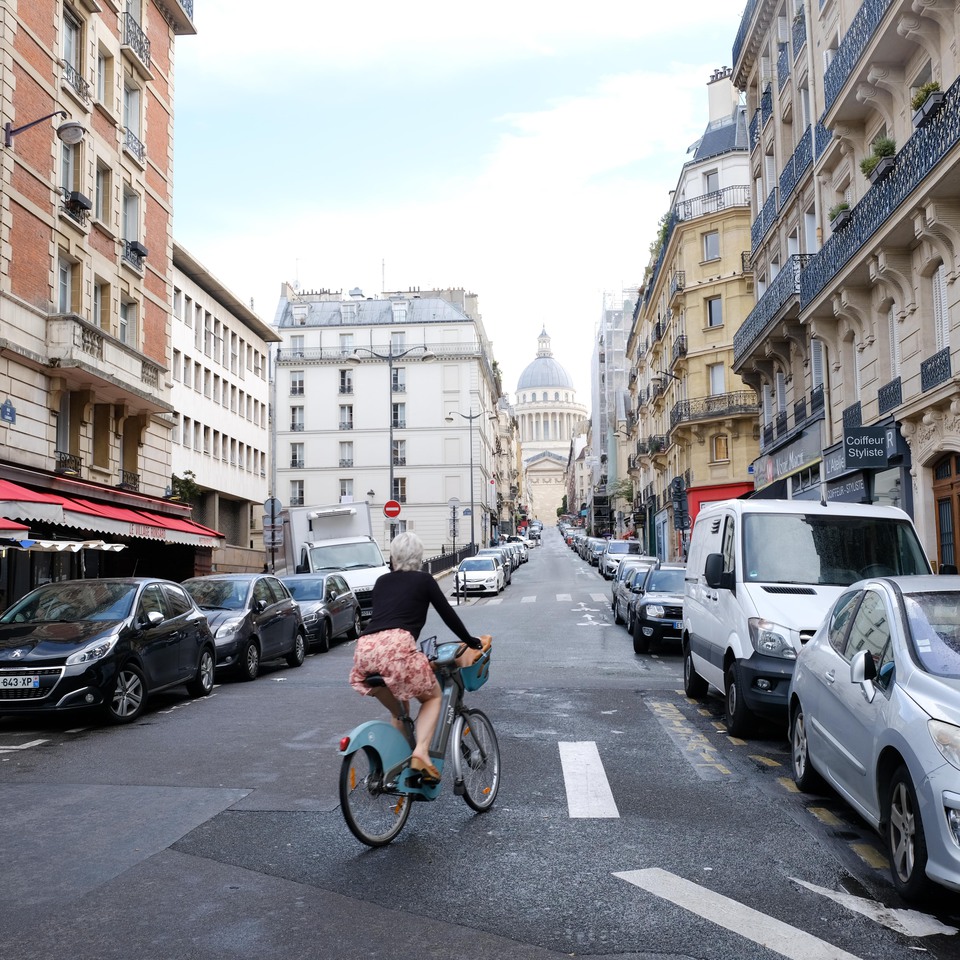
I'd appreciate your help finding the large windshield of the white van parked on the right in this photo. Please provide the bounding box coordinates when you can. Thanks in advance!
[743,513,930,587]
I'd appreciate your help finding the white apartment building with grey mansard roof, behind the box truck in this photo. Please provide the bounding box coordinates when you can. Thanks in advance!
[274,284,499,557]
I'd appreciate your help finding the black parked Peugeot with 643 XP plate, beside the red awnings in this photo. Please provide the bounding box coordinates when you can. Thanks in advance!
[0,577,216,723]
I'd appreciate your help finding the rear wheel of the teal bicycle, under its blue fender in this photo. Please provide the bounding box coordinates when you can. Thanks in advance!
[340,749,410,847]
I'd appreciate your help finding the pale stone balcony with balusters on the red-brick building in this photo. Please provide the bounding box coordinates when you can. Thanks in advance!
[46,313,173,413]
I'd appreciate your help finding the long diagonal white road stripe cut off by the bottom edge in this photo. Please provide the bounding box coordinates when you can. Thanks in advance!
[614,867,859,960]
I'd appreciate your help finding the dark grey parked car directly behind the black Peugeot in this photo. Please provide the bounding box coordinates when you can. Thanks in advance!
[183,573,307,680]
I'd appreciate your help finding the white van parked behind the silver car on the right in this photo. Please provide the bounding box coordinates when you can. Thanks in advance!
[682,500,932,736]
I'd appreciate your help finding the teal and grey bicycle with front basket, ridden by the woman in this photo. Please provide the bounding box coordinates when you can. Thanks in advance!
[339,637,500,847]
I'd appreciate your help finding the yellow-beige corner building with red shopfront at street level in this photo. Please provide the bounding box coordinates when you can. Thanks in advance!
[627,70,758,559]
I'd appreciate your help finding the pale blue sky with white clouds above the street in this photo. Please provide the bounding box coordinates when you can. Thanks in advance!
[174,0,744,407]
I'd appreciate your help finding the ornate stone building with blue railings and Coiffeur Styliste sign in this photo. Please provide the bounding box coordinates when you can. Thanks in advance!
[734,0,960,564]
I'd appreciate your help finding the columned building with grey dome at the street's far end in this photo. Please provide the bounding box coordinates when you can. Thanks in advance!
[515,329,587,523]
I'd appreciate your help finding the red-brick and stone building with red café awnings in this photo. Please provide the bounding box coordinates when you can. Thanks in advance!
[0,0,222,605]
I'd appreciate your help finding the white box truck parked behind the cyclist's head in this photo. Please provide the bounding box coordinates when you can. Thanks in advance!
[278,501,389,620]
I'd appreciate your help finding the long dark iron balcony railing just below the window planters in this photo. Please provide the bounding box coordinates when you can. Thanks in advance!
[800,73,960,307]
